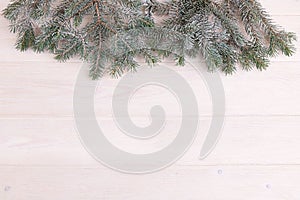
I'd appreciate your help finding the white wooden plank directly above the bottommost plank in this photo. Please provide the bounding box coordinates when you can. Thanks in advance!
[0,117,300,166]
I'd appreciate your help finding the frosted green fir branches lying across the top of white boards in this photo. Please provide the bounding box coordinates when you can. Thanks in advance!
[3,0,296,79]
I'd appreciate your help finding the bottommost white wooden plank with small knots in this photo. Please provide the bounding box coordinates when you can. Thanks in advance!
[0,166,300,200]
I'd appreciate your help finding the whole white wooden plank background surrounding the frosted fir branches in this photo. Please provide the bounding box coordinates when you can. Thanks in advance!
[0,0,300,200]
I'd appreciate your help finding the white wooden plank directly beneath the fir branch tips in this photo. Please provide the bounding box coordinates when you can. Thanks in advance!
[0,61,300,118]
